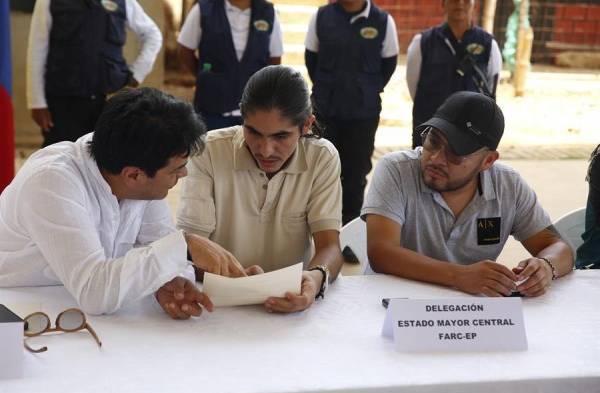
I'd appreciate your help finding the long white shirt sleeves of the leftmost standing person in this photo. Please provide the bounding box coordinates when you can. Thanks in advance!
[27,0,162,109]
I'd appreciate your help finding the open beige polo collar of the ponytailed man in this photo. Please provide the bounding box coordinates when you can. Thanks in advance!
[233,126,308,173]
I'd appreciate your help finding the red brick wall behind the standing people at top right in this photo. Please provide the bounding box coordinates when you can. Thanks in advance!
[374,0,600,63]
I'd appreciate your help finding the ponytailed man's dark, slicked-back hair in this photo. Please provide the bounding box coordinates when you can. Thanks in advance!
[240,65,319,135]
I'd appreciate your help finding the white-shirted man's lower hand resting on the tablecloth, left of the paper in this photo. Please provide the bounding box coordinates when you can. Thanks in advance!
[155,277,213,319]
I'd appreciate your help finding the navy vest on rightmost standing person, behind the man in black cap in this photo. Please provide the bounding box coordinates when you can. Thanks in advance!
[413,23,493,128]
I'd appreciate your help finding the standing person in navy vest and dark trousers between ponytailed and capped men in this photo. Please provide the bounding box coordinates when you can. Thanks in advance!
[305,0,398,224]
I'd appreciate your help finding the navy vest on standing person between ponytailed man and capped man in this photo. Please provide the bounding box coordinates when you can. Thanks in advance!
[312,3,388,119]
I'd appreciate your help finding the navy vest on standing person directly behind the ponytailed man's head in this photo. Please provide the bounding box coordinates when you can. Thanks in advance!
[194,0,275,114]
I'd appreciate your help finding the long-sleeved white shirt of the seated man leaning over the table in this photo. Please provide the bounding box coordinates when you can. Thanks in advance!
[0,134,190,314]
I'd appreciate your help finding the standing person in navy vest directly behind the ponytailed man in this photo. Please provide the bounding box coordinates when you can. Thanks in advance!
[177,0,283,130]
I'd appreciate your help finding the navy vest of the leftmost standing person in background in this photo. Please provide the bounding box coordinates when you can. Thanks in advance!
[45,0,130,97]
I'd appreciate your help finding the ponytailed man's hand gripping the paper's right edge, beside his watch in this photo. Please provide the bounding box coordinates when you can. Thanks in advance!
[265,270,323,313]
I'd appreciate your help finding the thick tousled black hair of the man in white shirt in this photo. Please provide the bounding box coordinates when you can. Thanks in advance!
[89,87,206,177]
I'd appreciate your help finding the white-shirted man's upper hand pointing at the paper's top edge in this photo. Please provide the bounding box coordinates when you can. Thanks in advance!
[185,233,247,277]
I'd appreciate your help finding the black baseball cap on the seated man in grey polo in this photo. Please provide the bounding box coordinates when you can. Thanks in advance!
[417,91,504,156]
